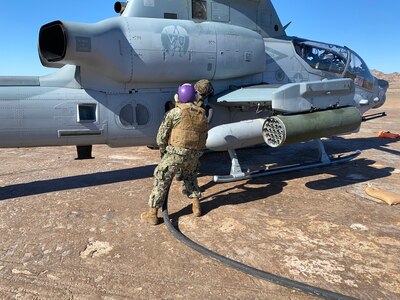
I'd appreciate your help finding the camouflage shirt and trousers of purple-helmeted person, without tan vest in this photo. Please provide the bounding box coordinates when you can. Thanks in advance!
[149,104,208,208]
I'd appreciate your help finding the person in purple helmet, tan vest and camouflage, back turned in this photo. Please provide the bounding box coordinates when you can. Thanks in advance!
[141,83,207,225]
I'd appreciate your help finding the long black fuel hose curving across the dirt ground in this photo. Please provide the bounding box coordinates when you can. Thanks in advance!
[162,188,356,300]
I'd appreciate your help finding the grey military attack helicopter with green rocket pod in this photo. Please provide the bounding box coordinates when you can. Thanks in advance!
[0,0,389,182]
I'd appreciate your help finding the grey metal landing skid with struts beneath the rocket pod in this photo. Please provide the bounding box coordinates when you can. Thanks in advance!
[214,139,361,183]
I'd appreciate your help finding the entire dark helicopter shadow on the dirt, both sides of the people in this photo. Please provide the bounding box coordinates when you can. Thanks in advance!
[0,137,400,203]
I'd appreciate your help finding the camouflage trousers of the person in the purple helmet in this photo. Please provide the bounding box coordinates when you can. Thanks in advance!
[149,150,203,208]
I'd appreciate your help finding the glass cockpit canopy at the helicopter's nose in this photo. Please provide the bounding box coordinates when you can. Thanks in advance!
[293,38,374,90]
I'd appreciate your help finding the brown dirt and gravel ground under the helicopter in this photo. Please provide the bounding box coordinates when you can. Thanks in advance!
[0,88,400,300]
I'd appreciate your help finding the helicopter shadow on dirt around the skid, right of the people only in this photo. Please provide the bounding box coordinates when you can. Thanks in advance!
[188,137,400,217]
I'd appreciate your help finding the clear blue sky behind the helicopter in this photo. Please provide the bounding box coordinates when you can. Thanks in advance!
[0,0,400,75]
